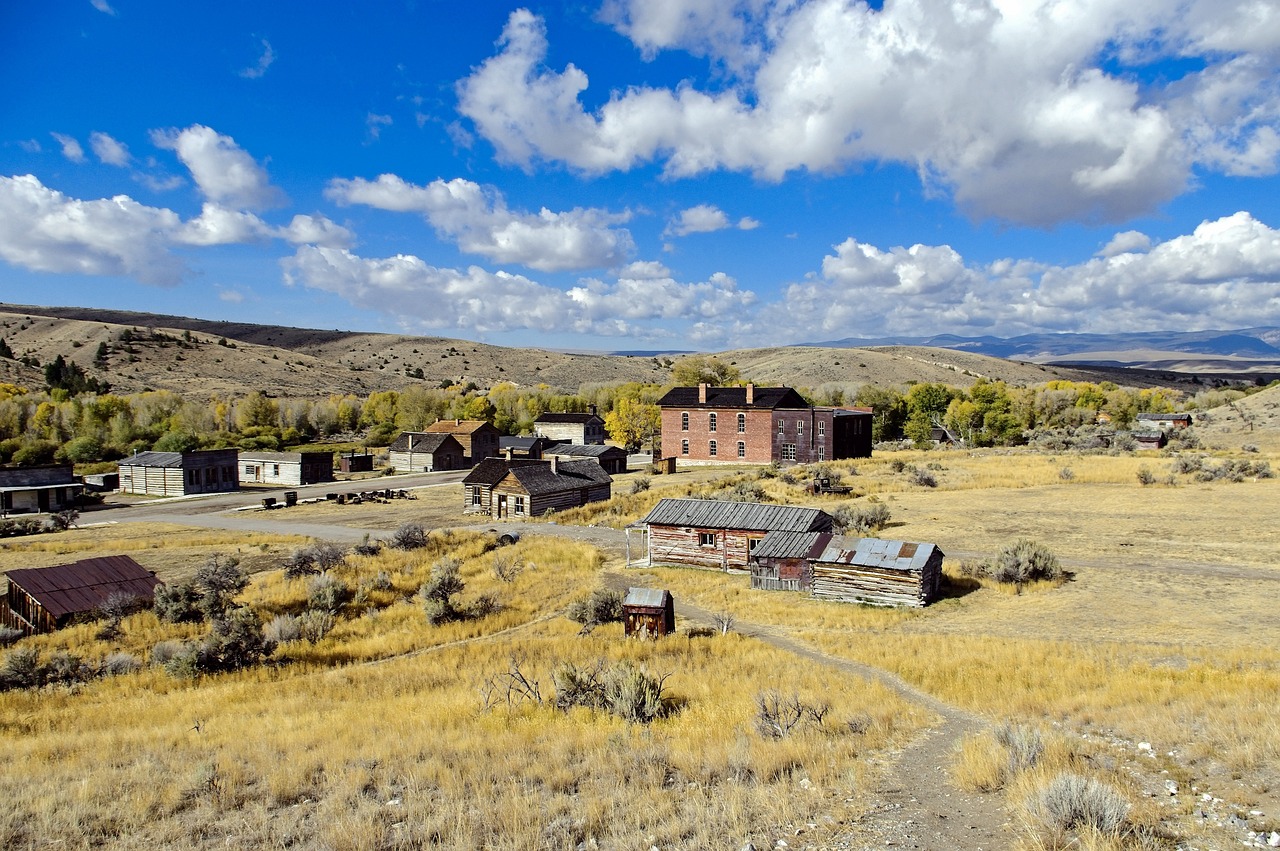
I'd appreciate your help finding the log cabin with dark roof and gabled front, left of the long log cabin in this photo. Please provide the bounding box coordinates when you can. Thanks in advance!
[462,458,613,520]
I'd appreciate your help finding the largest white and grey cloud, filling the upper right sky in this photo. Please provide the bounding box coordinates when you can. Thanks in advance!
[457,0,1280,225]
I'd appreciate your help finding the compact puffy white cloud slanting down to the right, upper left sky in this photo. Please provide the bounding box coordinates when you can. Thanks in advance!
[151,124,284,209]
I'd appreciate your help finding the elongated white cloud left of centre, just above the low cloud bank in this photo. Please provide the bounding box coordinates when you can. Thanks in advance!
[325,174,634,271]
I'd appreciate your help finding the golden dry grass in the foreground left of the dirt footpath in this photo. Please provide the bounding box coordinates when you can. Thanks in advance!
[0,535,927,848]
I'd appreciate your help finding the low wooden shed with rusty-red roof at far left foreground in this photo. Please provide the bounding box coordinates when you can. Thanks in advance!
[0,555,160,635]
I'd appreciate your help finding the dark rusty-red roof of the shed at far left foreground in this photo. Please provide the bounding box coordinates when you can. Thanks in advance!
[6,555,160,618]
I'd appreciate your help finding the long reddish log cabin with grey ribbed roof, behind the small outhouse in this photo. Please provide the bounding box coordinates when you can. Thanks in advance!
[628,499,831,571]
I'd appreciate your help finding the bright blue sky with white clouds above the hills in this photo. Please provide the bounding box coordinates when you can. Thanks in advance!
[0,0,1280,351]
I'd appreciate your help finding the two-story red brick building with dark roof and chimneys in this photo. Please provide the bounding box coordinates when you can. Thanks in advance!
[658,384,872,465]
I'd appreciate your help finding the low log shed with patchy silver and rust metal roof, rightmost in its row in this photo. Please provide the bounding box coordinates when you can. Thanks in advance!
[810,537,942,607]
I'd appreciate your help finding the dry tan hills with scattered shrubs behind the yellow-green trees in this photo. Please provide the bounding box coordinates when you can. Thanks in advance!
[0,305,1208,397]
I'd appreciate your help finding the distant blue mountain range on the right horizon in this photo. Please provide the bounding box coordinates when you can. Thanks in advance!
[800,326,1280,365]
